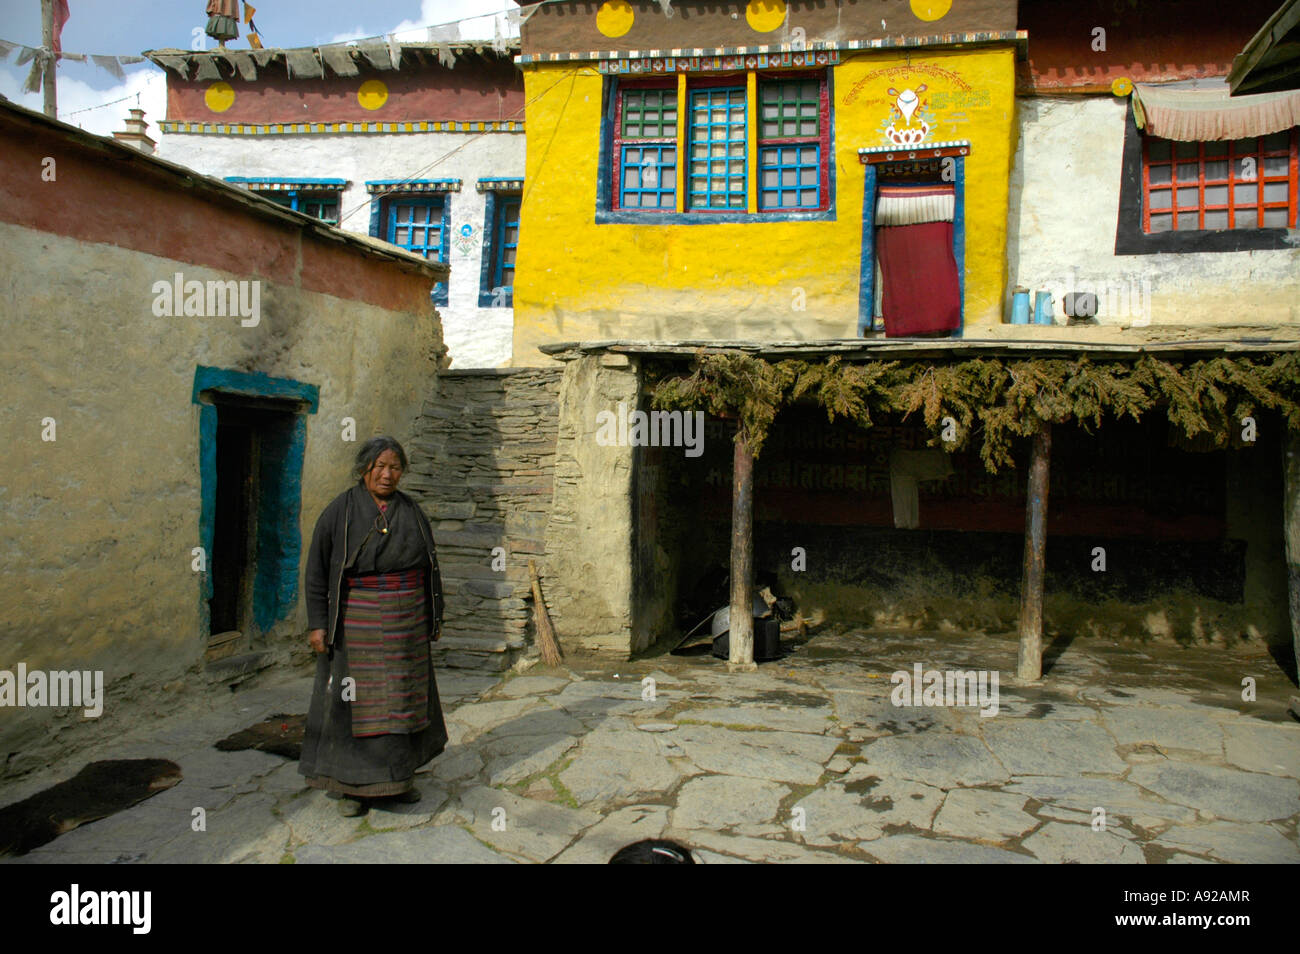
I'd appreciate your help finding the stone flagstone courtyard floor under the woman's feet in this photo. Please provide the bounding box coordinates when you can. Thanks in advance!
[3,629,1300,863]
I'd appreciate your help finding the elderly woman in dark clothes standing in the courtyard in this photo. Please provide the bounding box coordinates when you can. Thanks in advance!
[298,437,447,816]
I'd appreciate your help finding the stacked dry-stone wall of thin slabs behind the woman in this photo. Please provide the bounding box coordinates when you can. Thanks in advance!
[403,368,560,669]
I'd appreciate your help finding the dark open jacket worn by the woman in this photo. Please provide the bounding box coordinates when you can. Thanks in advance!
[304,483,443,646]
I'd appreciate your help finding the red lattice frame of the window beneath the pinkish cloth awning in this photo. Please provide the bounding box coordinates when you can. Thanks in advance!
[1141,129,1300,235]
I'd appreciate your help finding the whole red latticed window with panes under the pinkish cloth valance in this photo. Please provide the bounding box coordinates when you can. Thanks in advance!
[1143,129,1297,234]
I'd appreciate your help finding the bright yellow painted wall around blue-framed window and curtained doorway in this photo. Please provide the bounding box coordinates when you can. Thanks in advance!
[514,47,1015,365]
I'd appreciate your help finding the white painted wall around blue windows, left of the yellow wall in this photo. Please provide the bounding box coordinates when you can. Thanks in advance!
[156,131,524,368]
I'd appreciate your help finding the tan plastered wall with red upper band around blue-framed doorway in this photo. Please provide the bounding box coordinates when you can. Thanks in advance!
[0,104,445,775]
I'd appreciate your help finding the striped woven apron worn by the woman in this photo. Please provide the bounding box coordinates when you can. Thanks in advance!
[343,569,429,738]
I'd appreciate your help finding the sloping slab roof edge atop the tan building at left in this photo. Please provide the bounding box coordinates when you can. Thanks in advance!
[0,99,451,281]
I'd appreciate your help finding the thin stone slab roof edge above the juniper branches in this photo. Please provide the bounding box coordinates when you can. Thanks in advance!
[538,338,1300,361]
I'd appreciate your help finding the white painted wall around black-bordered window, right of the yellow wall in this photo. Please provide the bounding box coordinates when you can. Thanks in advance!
[1008,96,1300,337]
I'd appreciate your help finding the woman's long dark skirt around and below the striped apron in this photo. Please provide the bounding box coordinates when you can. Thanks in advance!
[298,579,447,798]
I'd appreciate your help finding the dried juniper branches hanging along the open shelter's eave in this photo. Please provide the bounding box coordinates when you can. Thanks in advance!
[651,351,1300,473]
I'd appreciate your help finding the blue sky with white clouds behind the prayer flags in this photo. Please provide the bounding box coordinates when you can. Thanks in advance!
[0,0,517,138]
